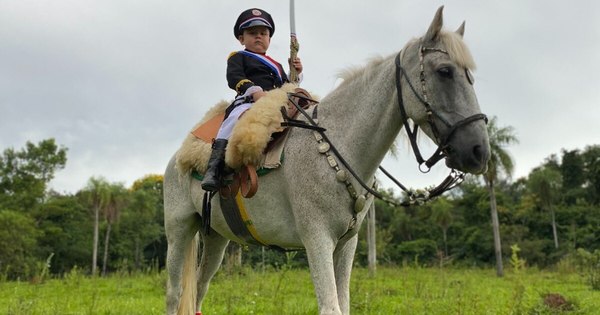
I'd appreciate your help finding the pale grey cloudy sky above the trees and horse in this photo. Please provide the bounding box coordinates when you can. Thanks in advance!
[0,0,600,193]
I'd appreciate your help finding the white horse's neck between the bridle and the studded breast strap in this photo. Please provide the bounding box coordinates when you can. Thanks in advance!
[319,57,402,179]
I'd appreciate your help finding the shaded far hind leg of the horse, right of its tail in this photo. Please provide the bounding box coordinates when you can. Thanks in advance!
[197,229,229,310]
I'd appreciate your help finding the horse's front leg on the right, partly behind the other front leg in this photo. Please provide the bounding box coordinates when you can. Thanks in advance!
[333,234,358,314]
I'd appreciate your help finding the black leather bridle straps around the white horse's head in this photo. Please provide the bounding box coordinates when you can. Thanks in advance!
[396,45,488,173]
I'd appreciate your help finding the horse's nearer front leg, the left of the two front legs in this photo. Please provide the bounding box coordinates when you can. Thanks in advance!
[303,228,342,315]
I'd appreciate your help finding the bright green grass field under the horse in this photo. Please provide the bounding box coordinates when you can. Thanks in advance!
[0,267,600,315]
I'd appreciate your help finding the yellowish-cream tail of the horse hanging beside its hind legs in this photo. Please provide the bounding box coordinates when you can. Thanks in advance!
[177,233,199,315]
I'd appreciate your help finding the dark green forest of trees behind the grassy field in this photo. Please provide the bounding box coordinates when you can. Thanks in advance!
[0,136,600,280]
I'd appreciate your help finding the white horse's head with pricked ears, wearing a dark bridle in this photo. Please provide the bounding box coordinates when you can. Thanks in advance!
[397,7,490,174]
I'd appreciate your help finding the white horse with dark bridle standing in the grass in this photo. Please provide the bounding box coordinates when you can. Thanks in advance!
[164,7,490,315]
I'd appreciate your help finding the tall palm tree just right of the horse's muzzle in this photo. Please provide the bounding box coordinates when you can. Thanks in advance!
[483,117,519,277]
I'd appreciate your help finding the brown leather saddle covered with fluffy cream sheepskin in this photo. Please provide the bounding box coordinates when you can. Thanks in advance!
[189,85,314,198]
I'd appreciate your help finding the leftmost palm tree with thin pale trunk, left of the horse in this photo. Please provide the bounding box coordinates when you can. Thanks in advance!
[81,177,110,275]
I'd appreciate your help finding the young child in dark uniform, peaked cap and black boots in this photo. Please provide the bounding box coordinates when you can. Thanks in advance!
[202,8,302,191]
